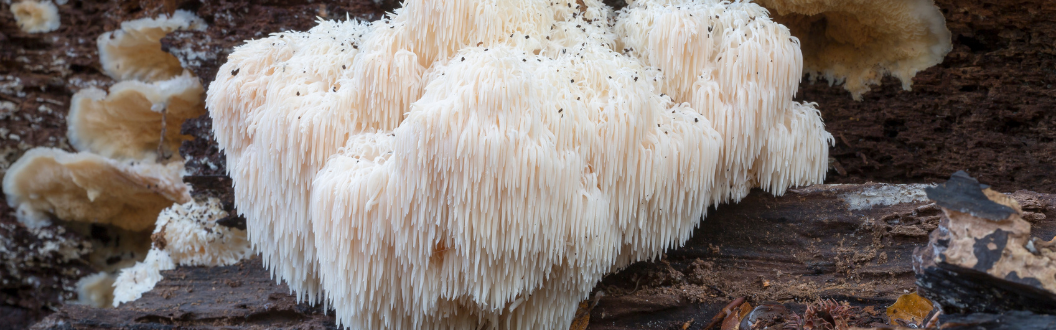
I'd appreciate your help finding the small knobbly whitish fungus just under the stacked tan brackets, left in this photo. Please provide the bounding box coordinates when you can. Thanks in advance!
[152,198,251,267]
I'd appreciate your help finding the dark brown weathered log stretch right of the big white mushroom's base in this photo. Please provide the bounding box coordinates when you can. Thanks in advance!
[591,184,941,329]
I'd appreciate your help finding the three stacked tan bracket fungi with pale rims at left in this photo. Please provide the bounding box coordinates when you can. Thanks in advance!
[3,11,205,231]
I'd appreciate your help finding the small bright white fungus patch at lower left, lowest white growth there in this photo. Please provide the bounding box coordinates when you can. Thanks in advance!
[113,249,176,307]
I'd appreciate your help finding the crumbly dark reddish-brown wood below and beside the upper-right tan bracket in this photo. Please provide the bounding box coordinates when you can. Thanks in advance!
[811,0,1056,193]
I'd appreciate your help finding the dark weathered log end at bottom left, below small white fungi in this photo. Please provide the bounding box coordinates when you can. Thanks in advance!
[28,258,336,329]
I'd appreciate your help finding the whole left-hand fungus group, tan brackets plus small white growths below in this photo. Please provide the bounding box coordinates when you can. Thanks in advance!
[3,11,222,307]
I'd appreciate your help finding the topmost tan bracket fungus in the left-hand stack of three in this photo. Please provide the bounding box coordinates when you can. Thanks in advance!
[96,10,206,81]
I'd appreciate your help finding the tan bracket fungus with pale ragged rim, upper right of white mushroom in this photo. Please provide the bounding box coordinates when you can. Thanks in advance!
[756,0,953,99]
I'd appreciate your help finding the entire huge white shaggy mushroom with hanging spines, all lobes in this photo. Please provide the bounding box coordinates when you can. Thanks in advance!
[206,0,831,329]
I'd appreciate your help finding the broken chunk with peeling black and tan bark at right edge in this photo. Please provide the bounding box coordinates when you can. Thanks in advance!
[914,171,1056,314]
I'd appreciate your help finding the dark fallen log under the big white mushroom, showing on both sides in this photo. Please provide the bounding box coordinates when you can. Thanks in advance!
[28,184,1056,329]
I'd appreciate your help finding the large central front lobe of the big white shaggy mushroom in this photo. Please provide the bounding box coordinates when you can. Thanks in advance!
[309,45,719,328]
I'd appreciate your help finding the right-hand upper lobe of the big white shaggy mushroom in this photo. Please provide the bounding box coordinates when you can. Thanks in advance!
[616,1,832,203]
